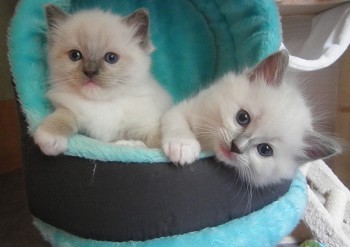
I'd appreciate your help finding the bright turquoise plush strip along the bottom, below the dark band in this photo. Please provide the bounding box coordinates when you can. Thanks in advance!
[34,174,307,247]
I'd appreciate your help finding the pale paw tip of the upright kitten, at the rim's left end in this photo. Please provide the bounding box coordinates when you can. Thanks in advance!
[34,127,68,155]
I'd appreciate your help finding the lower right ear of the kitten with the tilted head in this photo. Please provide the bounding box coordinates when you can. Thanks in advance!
[298,131,342,164]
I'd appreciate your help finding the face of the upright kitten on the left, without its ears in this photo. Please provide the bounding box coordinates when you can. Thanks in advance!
[48,7,151,100]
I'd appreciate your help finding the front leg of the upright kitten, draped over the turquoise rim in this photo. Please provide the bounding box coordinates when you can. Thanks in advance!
[34,108,78,155]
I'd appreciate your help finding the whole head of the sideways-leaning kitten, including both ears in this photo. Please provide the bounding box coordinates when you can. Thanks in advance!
[205,52,341,186]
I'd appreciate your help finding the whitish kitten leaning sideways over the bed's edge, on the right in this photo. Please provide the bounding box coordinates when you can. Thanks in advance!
[162,51,341,186]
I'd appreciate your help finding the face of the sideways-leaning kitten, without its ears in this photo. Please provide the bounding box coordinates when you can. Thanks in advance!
[208,75,311,186]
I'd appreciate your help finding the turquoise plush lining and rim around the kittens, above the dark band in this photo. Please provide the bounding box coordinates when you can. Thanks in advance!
[9,0,281,163]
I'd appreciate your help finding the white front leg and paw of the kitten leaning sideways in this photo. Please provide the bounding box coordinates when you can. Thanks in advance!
[162,107,201,166]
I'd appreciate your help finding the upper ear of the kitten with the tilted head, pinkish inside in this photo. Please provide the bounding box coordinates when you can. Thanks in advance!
[248,50,289,86]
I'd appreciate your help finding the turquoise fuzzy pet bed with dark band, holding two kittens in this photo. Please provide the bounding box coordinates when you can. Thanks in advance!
[9,0,306,247]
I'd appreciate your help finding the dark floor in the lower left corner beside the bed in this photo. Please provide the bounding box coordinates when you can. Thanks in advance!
[0,170,50,247]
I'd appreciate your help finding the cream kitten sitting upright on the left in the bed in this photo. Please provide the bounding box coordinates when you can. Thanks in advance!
[34,5,171,155]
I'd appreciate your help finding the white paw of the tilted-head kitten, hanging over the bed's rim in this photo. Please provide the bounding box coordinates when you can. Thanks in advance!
[163,138,201,166]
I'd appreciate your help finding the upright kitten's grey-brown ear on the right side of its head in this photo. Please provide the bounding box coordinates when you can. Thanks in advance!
[125,9,154,53]
